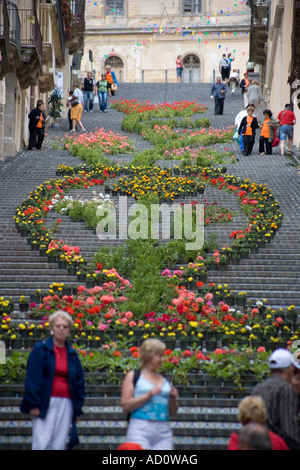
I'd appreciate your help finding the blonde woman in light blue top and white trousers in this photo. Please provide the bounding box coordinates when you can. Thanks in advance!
[121,338,178,450]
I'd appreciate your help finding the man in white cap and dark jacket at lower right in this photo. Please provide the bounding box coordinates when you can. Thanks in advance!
[252,348,300,450]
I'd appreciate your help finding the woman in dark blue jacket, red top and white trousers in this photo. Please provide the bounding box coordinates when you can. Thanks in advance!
[20,310,84,450]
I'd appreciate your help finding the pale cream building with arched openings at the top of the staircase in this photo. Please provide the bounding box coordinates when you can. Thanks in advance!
[82,0,250,83]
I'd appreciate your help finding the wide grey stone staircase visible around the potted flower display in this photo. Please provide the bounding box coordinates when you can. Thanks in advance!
[0,85,300,450]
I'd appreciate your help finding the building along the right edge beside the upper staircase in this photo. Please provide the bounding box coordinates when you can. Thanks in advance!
[247,0,300,146]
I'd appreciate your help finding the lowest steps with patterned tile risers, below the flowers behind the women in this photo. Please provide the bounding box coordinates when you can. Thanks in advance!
[0,388,243,450]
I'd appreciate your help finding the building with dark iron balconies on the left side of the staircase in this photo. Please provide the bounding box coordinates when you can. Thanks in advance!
[0,0,85,159]
